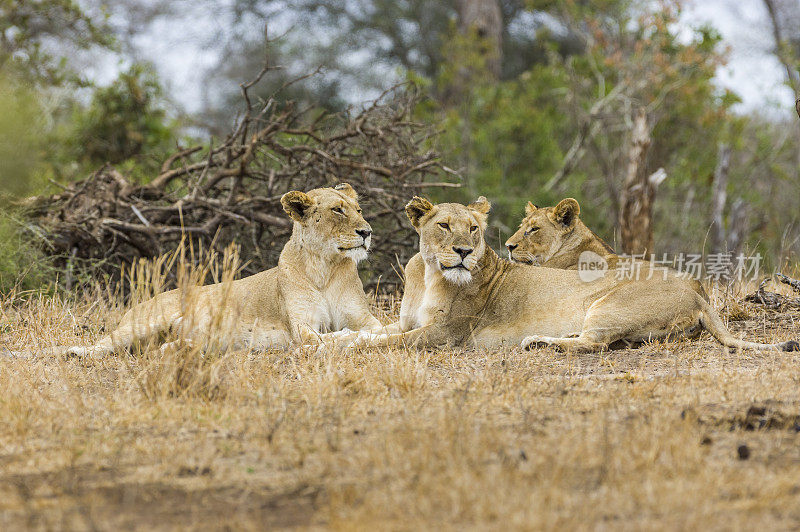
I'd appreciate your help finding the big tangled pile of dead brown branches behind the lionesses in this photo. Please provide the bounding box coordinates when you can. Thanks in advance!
[20,68,458,285]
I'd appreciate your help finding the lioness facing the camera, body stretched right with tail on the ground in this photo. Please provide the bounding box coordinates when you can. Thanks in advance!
[340,197,798,352]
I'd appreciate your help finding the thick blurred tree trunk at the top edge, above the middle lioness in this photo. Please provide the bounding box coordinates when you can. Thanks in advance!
[458,0,503,78]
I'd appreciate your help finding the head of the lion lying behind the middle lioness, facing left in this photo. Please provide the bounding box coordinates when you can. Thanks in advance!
[506,198,581,265]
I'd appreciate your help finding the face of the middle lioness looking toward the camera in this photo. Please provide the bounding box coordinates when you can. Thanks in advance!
[406,196,491,285]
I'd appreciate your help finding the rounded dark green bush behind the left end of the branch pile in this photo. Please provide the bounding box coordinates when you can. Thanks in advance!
[73,64,175,172]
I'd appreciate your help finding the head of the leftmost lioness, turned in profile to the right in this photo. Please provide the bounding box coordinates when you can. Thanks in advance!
[281,183,372,262]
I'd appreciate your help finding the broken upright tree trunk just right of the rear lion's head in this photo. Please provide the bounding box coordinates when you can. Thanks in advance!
[619,108,656,255]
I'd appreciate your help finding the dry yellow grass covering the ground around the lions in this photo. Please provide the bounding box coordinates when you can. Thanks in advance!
[0,268,800,529]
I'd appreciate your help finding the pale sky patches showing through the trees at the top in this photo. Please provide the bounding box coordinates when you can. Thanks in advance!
[81,0,800,117]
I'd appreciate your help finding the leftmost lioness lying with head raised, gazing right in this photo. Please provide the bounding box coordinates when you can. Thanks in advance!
[66,183,381,355]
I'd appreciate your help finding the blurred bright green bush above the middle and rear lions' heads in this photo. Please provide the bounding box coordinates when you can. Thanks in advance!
[428,66,565,228]
